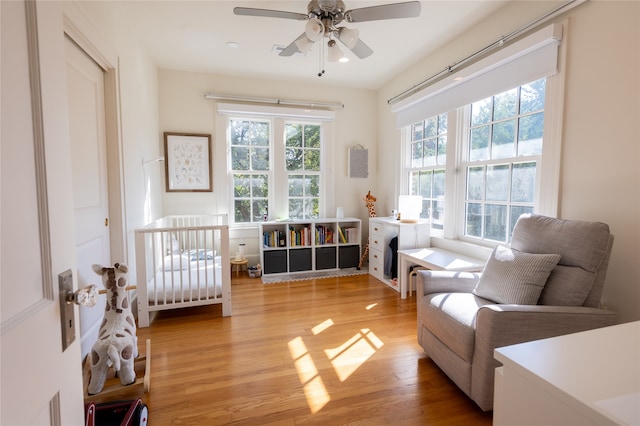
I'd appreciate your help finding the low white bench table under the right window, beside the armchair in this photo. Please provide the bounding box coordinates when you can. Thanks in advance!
[398,247,485,299]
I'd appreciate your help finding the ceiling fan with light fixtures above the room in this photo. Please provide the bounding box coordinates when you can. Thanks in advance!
[233,0,420,67]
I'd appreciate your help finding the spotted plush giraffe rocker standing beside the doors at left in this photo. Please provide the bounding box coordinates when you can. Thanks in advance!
[87,263,138,395]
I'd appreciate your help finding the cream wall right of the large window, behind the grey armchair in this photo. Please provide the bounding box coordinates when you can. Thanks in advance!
[560,1,640,321]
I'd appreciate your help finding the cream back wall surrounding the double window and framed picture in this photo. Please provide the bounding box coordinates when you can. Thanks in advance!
[157,70,377,263]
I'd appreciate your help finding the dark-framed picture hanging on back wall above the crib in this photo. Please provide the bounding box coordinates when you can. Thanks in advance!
[164,132,213,192]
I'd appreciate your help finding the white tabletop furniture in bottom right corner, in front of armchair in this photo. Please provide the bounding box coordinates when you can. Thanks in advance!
[493,321,640,426]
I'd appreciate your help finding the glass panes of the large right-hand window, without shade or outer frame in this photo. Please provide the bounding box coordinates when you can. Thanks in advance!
[405,79,546,242]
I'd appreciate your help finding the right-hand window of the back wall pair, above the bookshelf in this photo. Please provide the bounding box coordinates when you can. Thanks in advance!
[285,123,322,219]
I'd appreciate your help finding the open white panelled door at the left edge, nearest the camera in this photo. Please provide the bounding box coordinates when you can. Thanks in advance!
[0,1,84,426]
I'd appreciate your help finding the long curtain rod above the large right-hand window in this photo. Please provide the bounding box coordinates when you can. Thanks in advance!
[387,0,588,105]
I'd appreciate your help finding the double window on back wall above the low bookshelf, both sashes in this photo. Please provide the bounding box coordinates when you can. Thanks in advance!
[227,116,325,224]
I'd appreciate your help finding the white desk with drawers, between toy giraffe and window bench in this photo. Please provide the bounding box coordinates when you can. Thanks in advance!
[369,217,431,291]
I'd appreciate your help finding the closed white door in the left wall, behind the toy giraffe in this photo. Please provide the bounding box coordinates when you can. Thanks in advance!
[65,38,110,357]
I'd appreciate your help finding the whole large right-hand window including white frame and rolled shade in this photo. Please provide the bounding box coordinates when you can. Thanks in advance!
[389,23,566,246]
